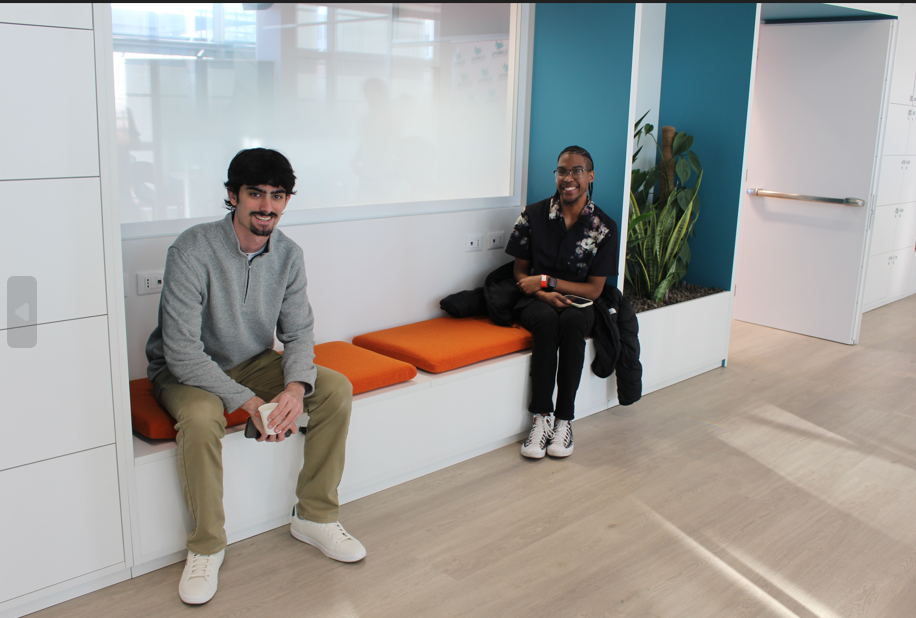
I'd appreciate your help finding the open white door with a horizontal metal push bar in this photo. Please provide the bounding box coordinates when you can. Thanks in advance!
[734,21,892,344]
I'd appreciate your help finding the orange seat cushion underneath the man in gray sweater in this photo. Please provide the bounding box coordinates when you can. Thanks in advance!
[130,341,417,440]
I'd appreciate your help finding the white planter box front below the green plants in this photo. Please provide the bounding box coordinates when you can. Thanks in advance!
[636,292,732,395]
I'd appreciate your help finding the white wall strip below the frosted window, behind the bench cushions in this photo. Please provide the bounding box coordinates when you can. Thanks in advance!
[122,207,520,380]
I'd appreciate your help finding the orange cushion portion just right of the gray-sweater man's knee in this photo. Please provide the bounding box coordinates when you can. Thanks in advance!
[315,341,417,395]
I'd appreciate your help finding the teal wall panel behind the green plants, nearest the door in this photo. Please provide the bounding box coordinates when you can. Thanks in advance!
[660,3,756,290]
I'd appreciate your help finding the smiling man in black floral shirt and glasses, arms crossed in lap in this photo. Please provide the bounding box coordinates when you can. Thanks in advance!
[506,146,617,459]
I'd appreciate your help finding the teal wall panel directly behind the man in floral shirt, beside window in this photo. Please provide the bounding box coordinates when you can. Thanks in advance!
[527,4,636,283]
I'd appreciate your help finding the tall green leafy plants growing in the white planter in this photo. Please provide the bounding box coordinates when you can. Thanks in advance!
[626,112,703,302]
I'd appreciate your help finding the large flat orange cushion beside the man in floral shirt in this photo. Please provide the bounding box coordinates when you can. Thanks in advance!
[353,316,532,373]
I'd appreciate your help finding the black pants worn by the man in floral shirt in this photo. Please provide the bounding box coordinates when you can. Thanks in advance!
[518,300,595,421]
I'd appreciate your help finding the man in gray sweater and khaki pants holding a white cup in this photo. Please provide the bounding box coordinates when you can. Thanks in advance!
[146,148,366,604]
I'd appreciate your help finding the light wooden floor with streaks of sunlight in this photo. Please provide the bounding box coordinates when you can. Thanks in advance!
[34,296,916,618]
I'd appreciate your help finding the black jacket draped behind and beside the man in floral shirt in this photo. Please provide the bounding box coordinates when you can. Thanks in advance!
[483,261,642,406]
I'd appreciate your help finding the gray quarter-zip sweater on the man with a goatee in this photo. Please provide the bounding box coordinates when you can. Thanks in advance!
[146,213,317,412]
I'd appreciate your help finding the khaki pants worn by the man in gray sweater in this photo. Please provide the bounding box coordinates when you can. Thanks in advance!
[153,350,353,555]
